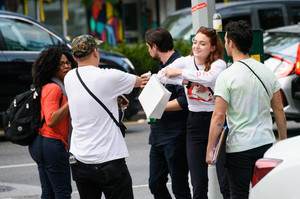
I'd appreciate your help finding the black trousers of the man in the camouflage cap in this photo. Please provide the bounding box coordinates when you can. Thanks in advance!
[71,158,133,199]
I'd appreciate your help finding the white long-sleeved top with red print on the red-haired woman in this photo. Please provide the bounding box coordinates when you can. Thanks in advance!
[161,56,226,112]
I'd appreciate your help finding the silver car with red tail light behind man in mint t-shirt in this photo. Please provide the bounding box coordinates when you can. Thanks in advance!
[264,25,300,122]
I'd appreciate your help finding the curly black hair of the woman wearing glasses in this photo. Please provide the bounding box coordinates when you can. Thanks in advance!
[32,47,76,86]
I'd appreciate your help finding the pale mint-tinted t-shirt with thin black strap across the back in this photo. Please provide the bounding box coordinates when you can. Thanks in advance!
[215,58,280,153]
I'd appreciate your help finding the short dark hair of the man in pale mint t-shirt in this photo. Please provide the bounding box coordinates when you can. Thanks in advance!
[225,20,253,54]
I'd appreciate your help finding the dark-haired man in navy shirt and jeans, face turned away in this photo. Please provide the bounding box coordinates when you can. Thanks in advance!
[141,28,191,199]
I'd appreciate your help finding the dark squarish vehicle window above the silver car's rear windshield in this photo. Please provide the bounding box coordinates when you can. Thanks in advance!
[258,8,284,30]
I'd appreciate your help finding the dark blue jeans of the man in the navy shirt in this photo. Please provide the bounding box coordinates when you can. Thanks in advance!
[149,139,191,199]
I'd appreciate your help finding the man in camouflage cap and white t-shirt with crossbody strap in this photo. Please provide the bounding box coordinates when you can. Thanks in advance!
[64,35,142,199]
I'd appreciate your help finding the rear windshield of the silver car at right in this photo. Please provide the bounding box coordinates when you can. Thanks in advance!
[264,32,300,57]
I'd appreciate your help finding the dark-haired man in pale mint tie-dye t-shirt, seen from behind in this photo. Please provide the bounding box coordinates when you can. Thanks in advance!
[206,21,286,199]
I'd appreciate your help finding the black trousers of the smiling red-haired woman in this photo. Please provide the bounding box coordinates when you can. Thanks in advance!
[186,112,230,199]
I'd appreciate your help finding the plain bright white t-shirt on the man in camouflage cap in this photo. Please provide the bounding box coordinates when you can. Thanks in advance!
[64,66,136,164]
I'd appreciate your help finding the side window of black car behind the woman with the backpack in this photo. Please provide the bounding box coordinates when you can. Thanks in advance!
[0,18,60,51]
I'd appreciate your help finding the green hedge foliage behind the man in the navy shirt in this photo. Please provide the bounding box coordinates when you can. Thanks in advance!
[101,40,191,75]
